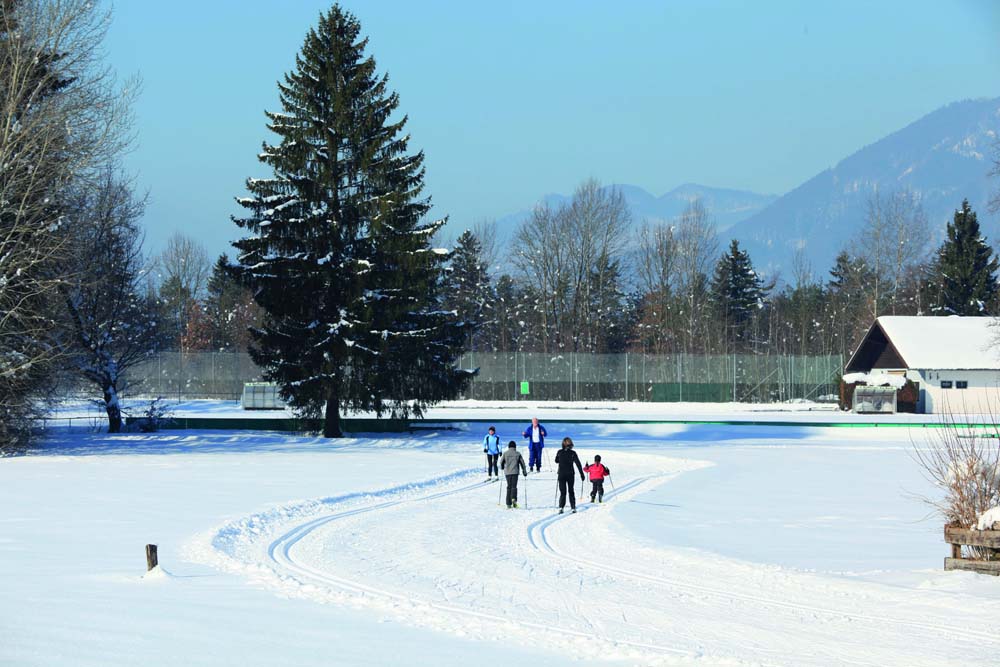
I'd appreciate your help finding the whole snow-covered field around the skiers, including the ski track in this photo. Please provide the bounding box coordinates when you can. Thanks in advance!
[0,424,1000,667]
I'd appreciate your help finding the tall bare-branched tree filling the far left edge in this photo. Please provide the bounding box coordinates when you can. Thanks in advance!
[0,0,134,447]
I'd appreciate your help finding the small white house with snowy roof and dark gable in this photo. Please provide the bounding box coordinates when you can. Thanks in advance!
[844,315,1000,416]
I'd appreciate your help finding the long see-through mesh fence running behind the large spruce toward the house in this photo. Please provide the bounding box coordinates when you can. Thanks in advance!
[121,352,843,403]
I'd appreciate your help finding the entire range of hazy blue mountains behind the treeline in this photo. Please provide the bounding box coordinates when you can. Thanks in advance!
[497,98,1000,274]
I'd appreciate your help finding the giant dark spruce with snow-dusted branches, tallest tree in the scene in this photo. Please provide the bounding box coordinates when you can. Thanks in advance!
[234,5,466,437]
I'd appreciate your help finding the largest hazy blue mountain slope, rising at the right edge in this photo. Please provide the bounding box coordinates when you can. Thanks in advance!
[726,98,1000,276]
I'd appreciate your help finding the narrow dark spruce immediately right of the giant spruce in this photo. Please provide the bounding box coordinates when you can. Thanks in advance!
[447,230,492,349]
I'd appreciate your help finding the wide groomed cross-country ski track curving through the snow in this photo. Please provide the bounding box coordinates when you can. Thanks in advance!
[188,452,1000,666]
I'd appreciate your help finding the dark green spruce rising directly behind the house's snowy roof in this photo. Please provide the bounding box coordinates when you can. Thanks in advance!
[931,199,1000,315]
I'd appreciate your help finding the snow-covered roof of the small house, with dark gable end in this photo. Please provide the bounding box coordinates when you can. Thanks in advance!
[847,315,1000,372]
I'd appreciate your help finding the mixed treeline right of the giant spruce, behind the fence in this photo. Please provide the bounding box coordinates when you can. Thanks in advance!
[448,181,1000,366]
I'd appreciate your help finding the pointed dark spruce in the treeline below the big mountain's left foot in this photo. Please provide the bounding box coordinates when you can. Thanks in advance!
[710,239,765,345]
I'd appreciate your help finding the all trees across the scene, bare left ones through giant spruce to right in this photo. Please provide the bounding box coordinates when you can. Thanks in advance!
[0,0,997,446]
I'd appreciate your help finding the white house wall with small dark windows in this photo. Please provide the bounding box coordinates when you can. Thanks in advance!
[906,370,1000,416]
